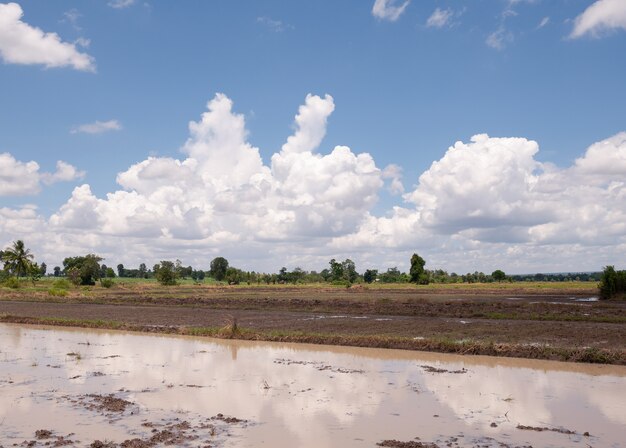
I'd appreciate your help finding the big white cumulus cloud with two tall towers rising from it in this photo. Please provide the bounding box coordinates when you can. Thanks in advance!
[51,94,383,250]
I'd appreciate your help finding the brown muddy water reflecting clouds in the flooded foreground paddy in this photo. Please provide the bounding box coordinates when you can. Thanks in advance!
[0,324,626,448]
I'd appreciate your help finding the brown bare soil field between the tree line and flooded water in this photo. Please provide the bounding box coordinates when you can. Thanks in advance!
[0,284,626,364]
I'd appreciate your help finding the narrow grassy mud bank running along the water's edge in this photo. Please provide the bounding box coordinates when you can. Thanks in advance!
[0,310,626,365]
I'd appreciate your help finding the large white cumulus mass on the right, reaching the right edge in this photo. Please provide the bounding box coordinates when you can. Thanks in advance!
[332,132,626,270]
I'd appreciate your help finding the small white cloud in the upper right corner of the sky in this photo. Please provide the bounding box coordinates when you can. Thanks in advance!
[569,0,626,39]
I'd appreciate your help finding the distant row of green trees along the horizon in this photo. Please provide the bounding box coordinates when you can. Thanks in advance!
[0,240,626,298]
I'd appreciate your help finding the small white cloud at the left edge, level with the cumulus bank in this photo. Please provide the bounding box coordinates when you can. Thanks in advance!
[0,152,85,196]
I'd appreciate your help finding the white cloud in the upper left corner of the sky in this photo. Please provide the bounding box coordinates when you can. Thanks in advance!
[0,3,96,72]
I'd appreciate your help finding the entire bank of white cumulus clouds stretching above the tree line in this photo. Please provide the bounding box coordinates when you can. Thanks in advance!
[0,94,626,272]
